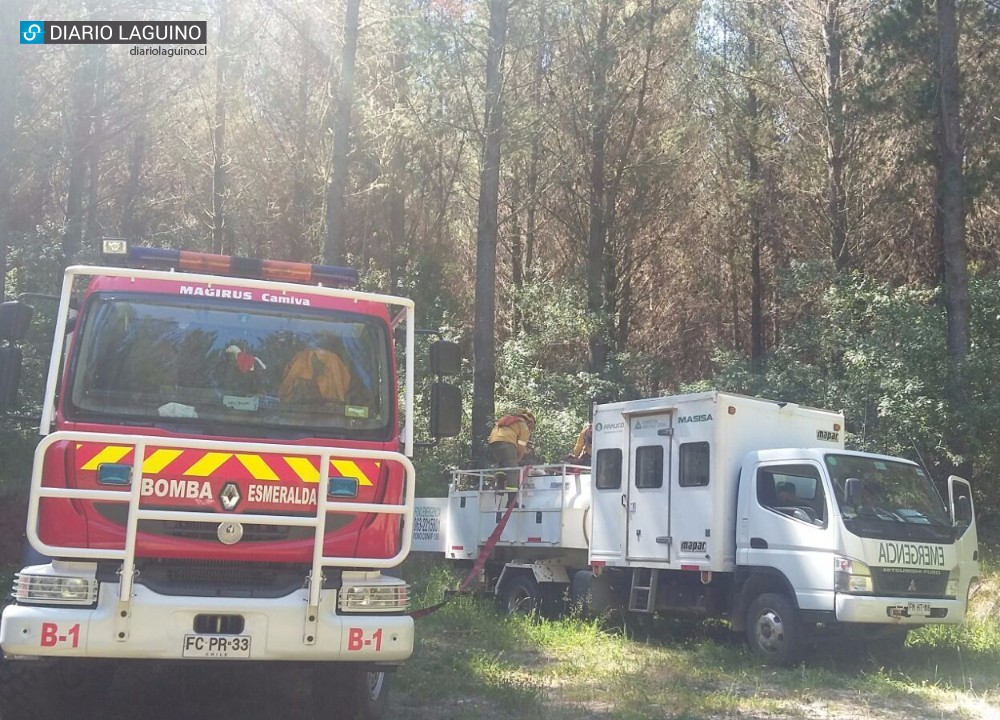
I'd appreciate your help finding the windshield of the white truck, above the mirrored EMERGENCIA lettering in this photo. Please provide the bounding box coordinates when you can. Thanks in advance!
[826,454,952,539]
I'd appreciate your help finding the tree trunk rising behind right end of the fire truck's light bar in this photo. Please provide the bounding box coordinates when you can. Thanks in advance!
[323,0,361,265]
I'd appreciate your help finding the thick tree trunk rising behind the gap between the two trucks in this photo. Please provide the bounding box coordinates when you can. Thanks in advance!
[472,0,509,460]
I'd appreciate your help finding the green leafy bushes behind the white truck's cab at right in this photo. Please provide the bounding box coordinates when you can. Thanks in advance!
[686,266,1000,512]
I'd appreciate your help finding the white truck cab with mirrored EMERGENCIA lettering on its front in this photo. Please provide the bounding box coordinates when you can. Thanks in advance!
[736,449,979,654]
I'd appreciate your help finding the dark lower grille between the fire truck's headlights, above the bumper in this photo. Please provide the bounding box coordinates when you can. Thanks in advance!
[127,559,334,598]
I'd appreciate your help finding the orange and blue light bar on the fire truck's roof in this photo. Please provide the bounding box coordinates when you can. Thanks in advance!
[105,242,358,288]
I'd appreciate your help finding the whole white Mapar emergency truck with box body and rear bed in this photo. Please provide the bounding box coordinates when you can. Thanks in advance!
[415,391,979,665]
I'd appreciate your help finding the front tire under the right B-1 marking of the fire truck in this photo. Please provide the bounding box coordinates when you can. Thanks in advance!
[310,663,389,720]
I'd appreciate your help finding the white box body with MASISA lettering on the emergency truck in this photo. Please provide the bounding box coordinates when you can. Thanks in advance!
[590,392,844,572]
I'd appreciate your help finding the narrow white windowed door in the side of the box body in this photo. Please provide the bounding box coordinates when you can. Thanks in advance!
[626,413,673,562]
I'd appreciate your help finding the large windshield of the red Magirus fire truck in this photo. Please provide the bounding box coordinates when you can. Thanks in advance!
[64,293,394,439]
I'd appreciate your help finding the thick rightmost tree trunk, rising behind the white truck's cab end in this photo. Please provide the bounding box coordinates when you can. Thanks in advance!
[936,0,971,471]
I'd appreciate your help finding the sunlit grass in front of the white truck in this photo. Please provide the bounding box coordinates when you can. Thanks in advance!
[395,567,1000,720]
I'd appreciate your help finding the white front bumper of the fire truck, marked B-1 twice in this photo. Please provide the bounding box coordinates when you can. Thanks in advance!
[0,578,413,663]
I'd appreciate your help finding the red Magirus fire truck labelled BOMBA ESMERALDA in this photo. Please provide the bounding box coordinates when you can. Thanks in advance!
[0,241,460,720]
